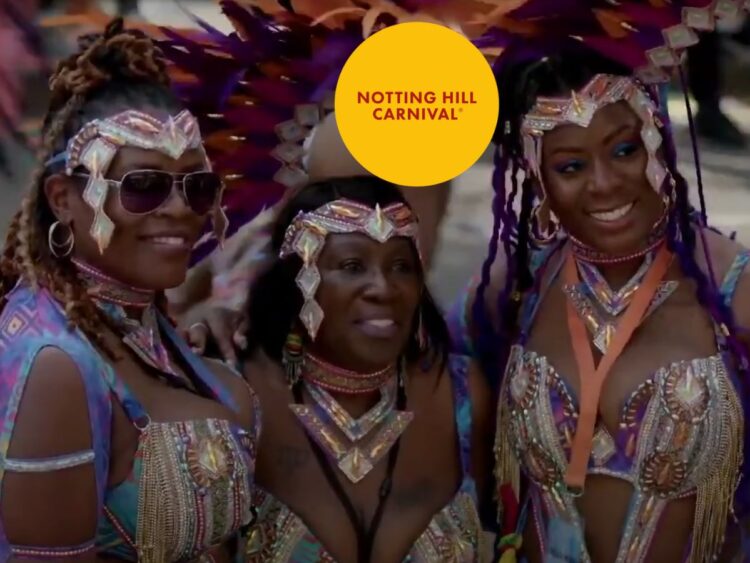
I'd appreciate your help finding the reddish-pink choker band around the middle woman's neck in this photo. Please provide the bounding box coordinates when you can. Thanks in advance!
[302,353,396,395]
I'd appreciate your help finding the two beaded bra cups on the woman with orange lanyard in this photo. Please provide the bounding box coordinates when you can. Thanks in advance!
[504,346,737,484]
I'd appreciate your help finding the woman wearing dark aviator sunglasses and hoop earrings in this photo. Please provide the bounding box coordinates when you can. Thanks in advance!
[0,20,258,563]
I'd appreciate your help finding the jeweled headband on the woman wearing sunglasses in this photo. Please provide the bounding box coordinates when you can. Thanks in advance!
[47,110,221,252]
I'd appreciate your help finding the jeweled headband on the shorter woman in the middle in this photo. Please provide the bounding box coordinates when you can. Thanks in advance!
[279,199,421,340]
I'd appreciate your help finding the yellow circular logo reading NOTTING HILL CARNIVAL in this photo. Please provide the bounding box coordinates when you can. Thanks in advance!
[334,22,499,186]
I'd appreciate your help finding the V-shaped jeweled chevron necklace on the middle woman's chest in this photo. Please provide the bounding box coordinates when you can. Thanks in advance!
[289,377,414,483]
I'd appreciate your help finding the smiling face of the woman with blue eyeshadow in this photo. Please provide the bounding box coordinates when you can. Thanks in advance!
[542,102,666,256]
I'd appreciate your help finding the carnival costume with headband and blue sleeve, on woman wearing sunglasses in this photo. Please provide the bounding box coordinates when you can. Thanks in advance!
[0,110,259,563]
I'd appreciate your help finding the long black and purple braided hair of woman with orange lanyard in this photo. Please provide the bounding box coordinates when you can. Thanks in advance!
[471,47,748,404]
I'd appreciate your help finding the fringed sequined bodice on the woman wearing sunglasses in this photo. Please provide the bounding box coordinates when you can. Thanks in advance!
[97,419,255,562]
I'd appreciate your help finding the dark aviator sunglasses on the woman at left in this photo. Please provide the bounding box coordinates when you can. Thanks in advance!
[75,170,224,215]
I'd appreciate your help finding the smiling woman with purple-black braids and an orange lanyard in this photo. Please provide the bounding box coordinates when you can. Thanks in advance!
[455,42,750,563]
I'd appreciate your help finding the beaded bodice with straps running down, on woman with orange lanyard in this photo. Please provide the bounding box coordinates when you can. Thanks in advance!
[502,346,742,561]
